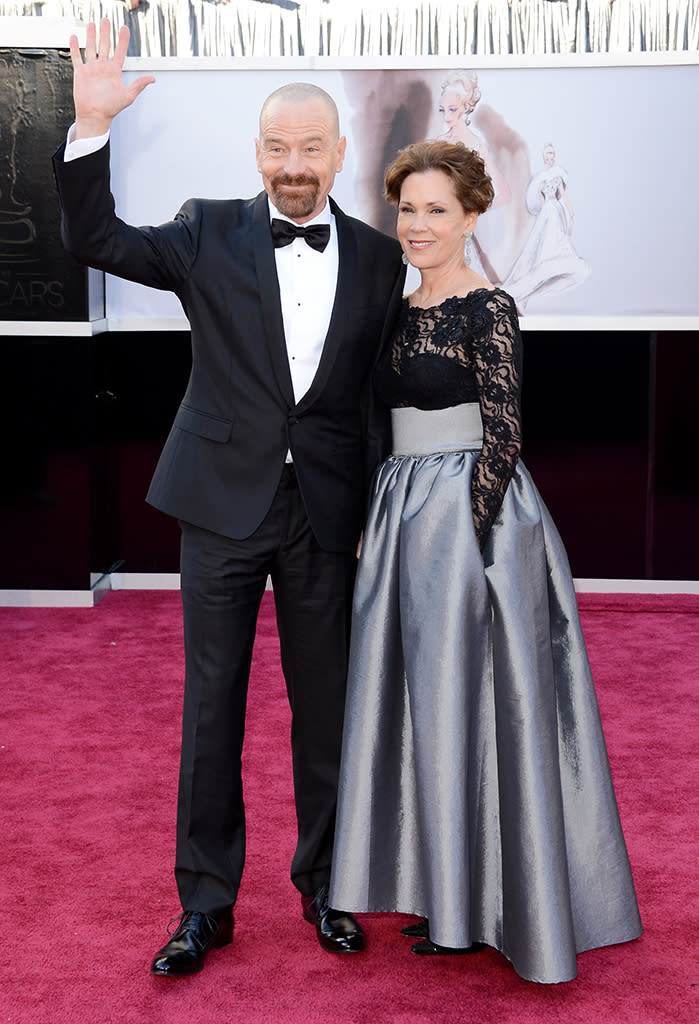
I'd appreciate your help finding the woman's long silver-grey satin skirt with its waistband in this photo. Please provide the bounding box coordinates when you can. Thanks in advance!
[331,406,642,982]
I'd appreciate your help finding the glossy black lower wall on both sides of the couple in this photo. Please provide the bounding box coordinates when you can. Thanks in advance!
[0,323,699,589]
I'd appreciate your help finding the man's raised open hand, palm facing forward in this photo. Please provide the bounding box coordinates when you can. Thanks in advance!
[70,17,156,138]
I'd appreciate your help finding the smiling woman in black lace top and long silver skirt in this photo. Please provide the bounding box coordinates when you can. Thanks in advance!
[331,140,641,982]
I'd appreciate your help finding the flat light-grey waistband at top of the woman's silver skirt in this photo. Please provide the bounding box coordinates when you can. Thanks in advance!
[391,401,483,455]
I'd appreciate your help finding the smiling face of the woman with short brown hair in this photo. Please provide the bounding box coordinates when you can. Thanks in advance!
[397,170,478,270]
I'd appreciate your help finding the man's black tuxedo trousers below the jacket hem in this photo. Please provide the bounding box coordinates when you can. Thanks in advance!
[175,466,356,912]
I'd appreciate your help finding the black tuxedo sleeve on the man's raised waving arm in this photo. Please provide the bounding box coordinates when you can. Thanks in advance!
[53,143,196,293]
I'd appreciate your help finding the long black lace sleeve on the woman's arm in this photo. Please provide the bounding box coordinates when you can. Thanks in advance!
[471,290,522,551]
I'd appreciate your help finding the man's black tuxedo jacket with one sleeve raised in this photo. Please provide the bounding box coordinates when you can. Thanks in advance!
[54,145,404,551]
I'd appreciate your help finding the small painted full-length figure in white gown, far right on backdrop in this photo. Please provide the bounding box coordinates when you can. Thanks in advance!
[503,142,589,312]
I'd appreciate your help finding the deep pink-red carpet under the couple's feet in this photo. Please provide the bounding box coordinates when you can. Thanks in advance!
[0,592,699,1024]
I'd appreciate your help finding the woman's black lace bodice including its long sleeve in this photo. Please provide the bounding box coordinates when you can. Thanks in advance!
[375,288,522,549]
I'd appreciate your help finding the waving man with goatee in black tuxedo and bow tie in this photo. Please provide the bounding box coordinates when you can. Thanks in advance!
[54,19,403,976]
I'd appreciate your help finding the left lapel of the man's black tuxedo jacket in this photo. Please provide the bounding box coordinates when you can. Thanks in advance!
[253,193,295,406]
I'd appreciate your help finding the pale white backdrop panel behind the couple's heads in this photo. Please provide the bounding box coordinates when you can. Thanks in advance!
[106,58,699,329]
